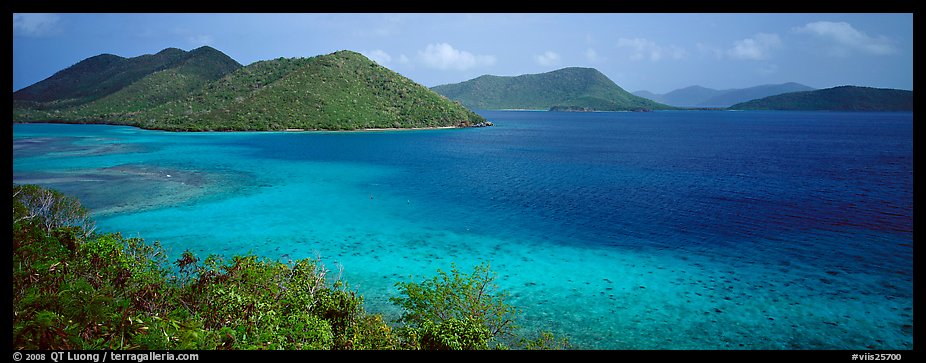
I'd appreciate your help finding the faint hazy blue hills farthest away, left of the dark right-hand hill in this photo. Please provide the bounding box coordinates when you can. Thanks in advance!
[633,82,814,108]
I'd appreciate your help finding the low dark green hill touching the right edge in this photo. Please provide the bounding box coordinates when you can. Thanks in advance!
[730,86,913,111]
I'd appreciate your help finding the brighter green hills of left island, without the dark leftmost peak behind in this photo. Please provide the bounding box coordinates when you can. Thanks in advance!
[14,51,486,131]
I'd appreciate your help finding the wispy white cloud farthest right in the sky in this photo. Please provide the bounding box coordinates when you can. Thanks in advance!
[792,21,897,56]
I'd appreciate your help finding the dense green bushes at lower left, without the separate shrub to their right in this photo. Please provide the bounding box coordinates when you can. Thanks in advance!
[13,185,398,350]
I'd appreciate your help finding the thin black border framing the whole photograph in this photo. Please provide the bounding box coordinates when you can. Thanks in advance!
[7,0,923,362]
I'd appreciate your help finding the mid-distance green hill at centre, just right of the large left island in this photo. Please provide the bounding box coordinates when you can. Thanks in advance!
[432,67,672,111]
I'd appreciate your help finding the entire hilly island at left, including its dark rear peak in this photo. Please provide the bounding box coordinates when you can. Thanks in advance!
[13,47,491,131]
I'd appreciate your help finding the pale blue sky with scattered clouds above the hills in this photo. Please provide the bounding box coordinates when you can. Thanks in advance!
[12,13,913,94]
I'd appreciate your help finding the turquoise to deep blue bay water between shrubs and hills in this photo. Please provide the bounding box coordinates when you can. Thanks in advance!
[13,111,913,349]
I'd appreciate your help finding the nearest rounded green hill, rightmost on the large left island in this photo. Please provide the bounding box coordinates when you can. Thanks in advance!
[141,51,485,130]
